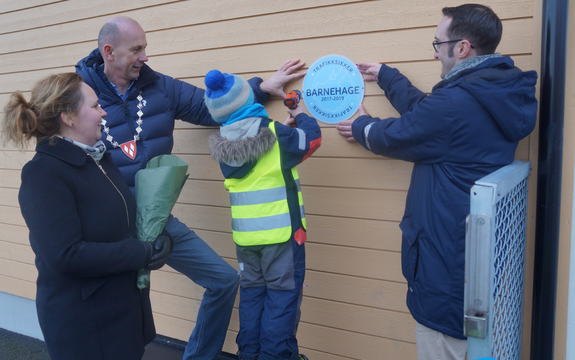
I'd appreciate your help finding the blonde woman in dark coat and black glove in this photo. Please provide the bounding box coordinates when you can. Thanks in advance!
[2,73,171,360]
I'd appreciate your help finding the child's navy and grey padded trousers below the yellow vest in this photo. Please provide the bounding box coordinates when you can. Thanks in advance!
[236,239,305,360]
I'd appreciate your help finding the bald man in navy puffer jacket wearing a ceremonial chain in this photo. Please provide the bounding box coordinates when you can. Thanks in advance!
[76,17,304,360]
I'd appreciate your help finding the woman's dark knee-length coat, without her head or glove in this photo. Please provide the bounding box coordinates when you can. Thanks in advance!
[18,138,155,360]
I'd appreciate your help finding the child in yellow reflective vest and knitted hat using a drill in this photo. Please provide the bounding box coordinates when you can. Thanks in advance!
[205,70,321,360]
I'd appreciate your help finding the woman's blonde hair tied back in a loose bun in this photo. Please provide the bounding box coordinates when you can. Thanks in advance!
[2,72,83,146]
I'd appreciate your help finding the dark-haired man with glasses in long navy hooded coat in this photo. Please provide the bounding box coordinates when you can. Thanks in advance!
[338,4,537,360]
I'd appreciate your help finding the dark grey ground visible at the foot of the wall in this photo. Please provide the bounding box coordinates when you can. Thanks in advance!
[0,328,237,360]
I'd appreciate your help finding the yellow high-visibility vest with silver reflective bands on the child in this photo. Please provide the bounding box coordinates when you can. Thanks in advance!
[224,121,307,246]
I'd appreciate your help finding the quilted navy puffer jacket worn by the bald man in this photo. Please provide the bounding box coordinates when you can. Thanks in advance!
[76,49,268,189]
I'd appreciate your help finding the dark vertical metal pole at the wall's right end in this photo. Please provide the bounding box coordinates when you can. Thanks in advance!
[531,0,568,360]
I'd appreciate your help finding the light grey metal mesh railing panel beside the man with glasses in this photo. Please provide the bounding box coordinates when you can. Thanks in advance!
[464,161,530,360]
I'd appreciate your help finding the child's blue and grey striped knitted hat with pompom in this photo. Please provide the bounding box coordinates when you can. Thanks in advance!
[204,70,254,123]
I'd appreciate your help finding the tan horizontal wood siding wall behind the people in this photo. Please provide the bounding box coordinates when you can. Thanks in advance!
[0,0,538,360]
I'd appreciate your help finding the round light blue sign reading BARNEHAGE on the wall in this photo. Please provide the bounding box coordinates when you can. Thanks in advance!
[303,55,365,124]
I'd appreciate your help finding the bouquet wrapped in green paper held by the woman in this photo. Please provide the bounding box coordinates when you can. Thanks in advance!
[136,155,188,289]
